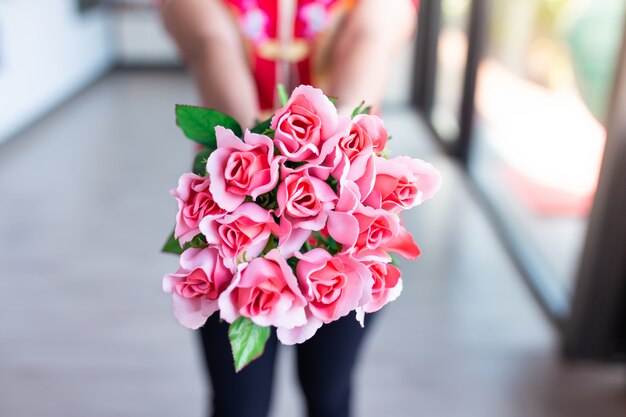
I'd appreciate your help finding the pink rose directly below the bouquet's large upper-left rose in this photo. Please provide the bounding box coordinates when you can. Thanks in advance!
[200,203,279,261]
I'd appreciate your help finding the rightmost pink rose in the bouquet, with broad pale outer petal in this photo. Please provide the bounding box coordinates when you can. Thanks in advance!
[363,156,441,213]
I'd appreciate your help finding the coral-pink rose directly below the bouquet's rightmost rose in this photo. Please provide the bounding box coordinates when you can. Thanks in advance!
[328,205,420,262]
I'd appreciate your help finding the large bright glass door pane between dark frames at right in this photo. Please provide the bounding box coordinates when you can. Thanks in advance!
[468,0,626,318]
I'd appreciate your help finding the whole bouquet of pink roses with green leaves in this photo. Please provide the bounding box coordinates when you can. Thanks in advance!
[163,85,441,371]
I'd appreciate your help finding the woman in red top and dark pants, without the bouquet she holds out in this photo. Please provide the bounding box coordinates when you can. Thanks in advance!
[161,0,417,417]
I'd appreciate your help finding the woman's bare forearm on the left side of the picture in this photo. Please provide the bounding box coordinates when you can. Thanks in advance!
[161,0,259,128]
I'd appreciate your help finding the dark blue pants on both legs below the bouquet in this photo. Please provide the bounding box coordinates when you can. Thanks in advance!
[200,313,372,417]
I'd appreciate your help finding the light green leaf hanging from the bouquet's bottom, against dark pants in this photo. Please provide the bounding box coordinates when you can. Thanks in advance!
[228,317,270,372]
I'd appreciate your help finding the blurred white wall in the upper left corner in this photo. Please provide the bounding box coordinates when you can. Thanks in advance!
[0,0,114,142]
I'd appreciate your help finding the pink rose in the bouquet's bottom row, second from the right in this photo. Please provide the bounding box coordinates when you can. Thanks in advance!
[296,248,374,323]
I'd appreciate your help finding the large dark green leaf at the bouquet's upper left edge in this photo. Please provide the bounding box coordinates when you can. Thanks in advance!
[176,104,243,149]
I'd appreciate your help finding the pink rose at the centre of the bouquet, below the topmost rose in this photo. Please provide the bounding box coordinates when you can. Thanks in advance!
[276,167,337,230]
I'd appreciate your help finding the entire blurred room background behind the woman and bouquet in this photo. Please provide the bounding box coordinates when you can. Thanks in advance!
[0,0,626,417]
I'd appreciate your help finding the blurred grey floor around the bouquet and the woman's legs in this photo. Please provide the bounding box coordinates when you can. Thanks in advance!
[0,73,626,417]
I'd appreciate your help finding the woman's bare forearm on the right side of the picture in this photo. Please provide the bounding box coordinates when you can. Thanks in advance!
[327,0,417,114]
